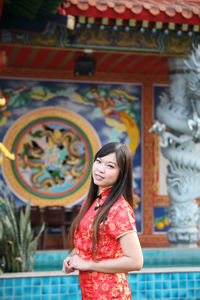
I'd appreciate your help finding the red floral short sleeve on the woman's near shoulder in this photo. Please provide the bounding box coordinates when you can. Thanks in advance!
[106,200,136,239]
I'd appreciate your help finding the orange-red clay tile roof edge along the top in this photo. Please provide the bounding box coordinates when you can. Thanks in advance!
[59,0,200,19]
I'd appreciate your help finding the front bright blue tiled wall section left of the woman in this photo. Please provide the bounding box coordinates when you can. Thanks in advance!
[0,276,81,300]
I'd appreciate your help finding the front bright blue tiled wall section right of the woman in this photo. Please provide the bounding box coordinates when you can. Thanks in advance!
[128,272,200,300]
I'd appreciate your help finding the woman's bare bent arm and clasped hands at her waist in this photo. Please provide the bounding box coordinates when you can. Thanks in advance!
[69,232,143,273]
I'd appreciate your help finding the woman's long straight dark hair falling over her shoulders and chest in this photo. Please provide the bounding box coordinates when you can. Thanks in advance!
[68,142,134,255]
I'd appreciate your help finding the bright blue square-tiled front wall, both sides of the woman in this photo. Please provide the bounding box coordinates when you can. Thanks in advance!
[0,272,200,300]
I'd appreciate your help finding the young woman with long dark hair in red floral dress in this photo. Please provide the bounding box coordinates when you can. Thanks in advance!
[63,143,143,300]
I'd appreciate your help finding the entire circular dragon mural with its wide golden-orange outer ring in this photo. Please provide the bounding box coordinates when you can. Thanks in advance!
[3,107,100,206]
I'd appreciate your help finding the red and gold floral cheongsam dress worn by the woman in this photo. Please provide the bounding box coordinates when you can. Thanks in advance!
[74,189,136,300]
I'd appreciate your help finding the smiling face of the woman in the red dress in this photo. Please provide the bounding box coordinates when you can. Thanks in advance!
[92,153,120,192]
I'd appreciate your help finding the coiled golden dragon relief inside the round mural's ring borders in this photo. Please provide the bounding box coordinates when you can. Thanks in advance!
[17,124,85,192]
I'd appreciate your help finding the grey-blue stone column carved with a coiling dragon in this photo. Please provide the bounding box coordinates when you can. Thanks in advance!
[150,45,200,247]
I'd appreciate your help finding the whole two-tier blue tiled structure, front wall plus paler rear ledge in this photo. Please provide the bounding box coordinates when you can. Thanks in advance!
[0,249,200,300]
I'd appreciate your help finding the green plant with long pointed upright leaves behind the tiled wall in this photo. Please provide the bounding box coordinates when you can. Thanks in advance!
[0,195,44,273]
